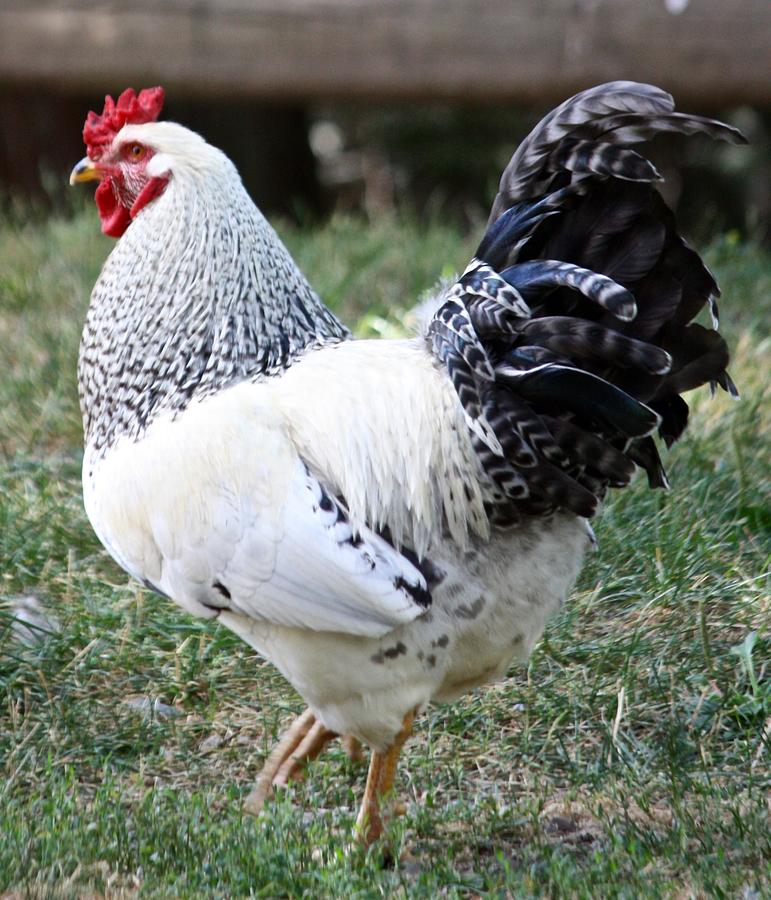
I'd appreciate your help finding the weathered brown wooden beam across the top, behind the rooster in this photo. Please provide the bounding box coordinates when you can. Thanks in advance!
[0,0,771,106]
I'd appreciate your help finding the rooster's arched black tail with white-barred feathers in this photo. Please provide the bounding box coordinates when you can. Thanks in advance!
[428,81,744,525]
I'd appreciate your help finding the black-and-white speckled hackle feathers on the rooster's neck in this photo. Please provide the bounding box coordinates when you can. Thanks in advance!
[79,111,348,452]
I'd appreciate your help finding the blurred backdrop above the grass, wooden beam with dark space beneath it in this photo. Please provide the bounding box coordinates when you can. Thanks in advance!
[0,0,771,240]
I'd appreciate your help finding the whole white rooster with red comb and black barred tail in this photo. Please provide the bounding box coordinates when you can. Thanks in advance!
[70,81,743,843]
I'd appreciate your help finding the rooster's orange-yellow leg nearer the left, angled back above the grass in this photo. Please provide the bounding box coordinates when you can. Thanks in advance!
[244,709,336,816]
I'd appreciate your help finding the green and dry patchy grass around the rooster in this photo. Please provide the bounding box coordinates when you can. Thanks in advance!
[0,204,771,898]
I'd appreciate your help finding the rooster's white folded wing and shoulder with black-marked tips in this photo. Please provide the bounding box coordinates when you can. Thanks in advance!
[84,385,430,637]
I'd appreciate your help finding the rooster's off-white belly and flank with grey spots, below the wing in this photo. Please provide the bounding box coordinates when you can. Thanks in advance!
[220,515,589,749]
